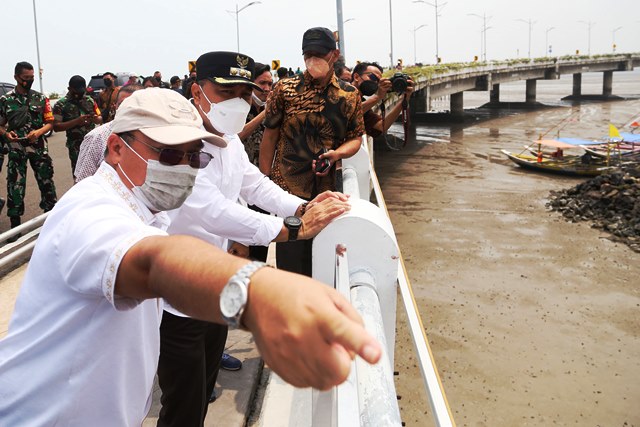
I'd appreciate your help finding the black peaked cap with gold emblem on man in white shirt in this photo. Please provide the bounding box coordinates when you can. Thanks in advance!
[196,52,262,90]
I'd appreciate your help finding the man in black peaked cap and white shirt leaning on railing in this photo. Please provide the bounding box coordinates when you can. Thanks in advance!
[158,52,350,427]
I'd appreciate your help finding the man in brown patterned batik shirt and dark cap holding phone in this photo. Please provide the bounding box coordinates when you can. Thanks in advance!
[260,27,364,276]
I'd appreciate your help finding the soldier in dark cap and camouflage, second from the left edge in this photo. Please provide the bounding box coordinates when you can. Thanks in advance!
[53,76,102,172]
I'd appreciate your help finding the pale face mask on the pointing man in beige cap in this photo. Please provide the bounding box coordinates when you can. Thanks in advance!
[118,139,198,212]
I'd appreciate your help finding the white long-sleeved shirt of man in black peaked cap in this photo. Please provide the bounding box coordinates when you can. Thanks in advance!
[165,135,304,317]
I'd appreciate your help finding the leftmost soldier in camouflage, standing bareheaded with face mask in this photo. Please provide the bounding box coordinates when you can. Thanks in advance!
[0,62,58,236]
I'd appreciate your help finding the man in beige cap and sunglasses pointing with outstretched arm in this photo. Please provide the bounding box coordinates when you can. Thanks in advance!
[0,89,381,427]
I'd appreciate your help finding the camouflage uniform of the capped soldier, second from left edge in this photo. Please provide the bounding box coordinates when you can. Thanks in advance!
[53,95,100,171]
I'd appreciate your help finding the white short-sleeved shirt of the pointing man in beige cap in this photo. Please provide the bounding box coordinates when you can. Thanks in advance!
[0,163,168,426]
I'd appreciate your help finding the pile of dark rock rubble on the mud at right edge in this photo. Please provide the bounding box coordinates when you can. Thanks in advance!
[547,164,640,252]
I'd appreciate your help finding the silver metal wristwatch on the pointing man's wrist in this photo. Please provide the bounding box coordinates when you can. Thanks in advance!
[220,261,267,329]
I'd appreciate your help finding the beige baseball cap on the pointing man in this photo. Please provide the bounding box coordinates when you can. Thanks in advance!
[111,88,227,147]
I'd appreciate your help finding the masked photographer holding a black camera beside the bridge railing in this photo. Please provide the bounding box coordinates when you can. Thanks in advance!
[352,62,414,139]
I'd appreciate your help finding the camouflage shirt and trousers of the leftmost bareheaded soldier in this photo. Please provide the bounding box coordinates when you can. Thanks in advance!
[0,90,58,217]
